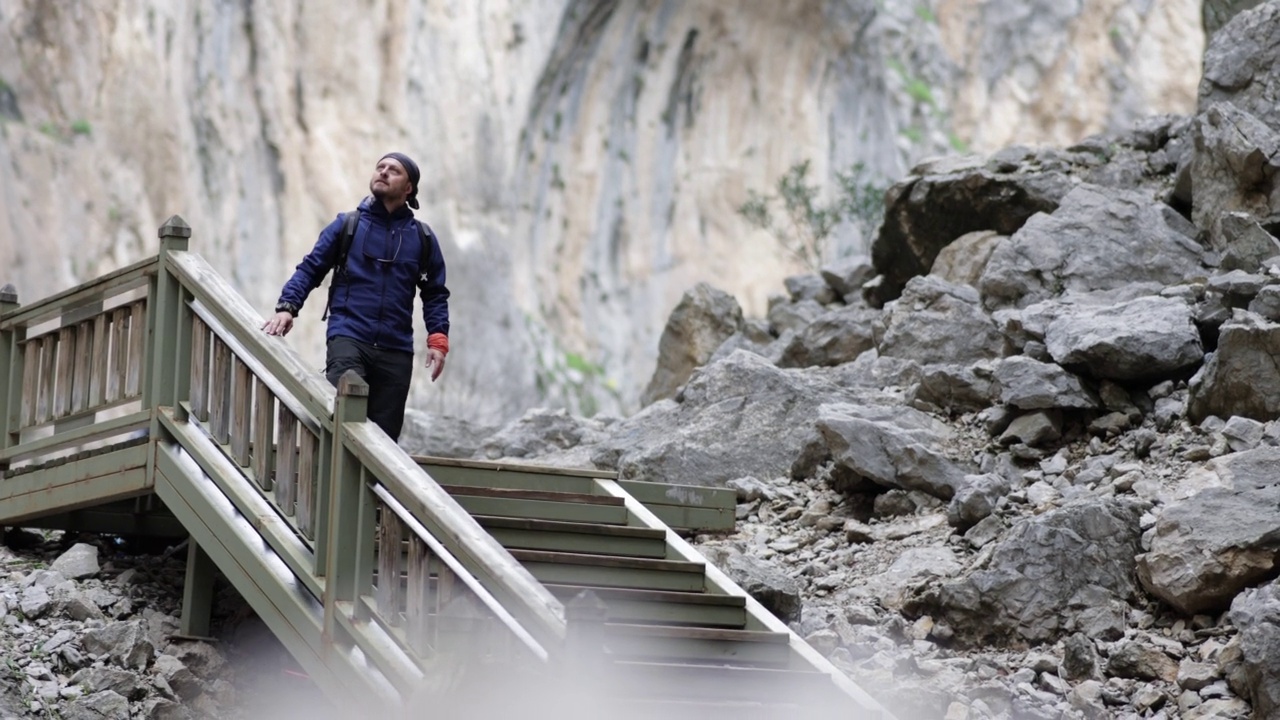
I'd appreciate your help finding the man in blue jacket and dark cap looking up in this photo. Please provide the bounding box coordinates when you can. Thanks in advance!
[262,152,449,439]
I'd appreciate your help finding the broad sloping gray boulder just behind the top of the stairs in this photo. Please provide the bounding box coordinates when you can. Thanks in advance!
[591,350,888,486]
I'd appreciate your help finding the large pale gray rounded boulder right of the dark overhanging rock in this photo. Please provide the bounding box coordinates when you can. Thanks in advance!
[979,184,1207,307]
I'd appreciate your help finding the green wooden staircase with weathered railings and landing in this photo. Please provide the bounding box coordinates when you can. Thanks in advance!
[0,217,892,720]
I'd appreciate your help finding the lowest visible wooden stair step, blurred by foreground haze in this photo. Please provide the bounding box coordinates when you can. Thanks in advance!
[608,661,856,702]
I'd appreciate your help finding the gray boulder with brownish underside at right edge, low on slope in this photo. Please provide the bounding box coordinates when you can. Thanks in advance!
[1138,486,1280,615]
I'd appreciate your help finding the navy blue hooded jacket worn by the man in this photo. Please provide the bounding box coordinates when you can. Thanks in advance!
[279,197,449,352]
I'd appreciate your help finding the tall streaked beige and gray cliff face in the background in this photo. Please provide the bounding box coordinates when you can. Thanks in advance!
[0,0,1203,420]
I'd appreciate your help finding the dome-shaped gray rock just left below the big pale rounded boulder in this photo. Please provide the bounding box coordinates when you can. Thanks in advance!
[877,275,1007,365]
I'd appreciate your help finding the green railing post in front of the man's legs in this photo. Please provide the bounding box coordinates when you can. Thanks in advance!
[324,370,375,644]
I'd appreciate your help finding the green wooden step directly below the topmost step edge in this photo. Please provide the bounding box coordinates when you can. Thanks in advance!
[444,486,627,525]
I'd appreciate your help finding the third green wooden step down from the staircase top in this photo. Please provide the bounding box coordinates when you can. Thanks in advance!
[475,515,667,559]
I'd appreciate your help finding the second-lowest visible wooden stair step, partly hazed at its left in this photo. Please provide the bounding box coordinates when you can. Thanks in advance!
[604,624,791,669]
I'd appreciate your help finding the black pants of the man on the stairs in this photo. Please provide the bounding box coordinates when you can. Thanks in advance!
[324,337,413,441]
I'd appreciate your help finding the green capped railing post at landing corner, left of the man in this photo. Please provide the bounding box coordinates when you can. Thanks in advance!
[142,215,191,412]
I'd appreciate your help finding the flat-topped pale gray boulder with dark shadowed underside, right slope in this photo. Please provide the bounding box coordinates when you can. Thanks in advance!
[1044,297,1204,380]
